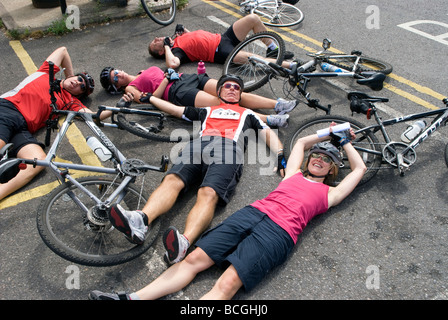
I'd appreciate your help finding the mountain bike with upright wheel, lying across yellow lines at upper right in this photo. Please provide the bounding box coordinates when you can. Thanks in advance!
[223,31,392,96]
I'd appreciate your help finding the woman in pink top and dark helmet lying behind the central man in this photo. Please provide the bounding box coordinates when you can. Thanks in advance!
[100,66,299,127]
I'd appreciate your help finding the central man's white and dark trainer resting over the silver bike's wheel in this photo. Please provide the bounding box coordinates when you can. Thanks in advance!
[109,204,148,244]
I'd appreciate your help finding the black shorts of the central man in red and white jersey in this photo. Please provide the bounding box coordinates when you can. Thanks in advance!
[167,137,244,205]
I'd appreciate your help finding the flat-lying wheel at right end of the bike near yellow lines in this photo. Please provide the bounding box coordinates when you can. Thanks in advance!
[322,53,393,74]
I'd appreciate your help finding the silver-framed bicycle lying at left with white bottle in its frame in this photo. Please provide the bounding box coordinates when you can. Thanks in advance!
[0,64,169,266]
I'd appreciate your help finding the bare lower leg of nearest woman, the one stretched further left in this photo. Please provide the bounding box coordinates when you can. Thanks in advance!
[136,248,214,300]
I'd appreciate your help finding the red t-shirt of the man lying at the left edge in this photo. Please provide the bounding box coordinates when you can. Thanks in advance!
[0,61,85,133]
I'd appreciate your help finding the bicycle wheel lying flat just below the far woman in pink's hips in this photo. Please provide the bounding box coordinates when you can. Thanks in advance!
[117,105,200,142]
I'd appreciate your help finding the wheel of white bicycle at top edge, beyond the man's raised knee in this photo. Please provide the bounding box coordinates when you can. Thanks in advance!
[254,1,304,27]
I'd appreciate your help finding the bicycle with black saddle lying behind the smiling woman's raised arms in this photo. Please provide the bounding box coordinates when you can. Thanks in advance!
[286,92,448,184]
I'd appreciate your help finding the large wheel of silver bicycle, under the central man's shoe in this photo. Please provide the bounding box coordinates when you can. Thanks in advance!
[37,177,160,267]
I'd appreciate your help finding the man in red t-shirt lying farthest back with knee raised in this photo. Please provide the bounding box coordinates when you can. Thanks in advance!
[148,14,294,69]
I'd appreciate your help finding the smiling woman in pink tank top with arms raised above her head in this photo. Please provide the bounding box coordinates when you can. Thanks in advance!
[90,126,366,300]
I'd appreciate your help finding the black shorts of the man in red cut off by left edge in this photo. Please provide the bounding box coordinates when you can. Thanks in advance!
[0,99,42,158]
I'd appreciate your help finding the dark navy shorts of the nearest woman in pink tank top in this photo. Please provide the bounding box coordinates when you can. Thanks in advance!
[196,206,294,291]
